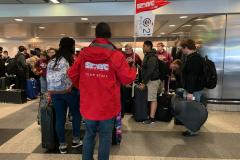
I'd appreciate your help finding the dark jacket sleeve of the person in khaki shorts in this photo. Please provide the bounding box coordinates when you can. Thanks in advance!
[142,56,158,85]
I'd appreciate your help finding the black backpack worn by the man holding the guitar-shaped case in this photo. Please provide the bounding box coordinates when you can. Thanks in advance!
[203,56,217,89]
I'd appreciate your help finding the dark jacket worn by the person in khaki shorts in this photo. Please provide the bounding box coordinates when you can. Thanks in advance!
[142,51,159,85]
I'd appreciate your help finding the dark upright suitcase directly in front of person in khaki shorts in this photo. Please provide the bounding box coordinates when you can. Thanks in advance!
[133,86,148,122]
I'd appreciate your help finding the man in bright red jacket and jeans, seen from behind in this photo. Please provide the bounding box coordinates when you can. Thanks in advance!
[68,23,136,160]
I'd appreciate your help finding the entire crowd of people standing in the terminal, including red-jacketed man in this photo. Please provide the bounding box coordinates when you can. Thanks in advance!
[0,23,204,160]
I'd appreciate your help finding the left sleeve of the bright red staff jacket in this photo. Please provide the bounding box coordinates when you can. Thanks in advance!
[68,55,81,88]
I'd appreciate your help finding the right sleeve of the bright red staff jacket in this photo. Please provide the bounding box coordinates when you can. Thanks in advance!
[113,54,136,85]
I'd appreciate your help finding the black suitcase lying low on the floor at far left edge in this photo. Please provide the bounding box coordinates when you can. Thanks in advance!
[0,89,27,104]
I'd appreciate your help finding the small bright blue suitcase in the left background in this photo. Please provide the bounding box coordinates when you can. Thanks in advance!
[26,78,38,99]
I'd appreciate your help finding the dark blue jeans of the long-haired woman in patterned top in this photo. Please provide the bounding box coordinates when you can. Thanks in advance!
[51,90,81,144]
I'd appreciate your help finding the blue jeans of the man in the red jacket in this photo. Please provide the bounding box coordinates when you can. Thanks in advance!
[82,119,114,160]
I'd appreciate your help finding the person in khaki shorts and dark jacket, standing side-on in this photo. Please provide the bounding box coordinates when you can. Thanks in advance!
[139,41,160,124]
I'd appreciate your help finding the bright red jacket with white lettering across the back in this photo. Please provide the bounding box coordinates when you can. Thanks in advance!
[68,38,136,121]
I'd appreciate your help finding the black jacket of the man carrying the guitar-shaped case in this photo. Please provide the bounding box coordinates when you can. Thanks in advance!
[183,52,204,93]
